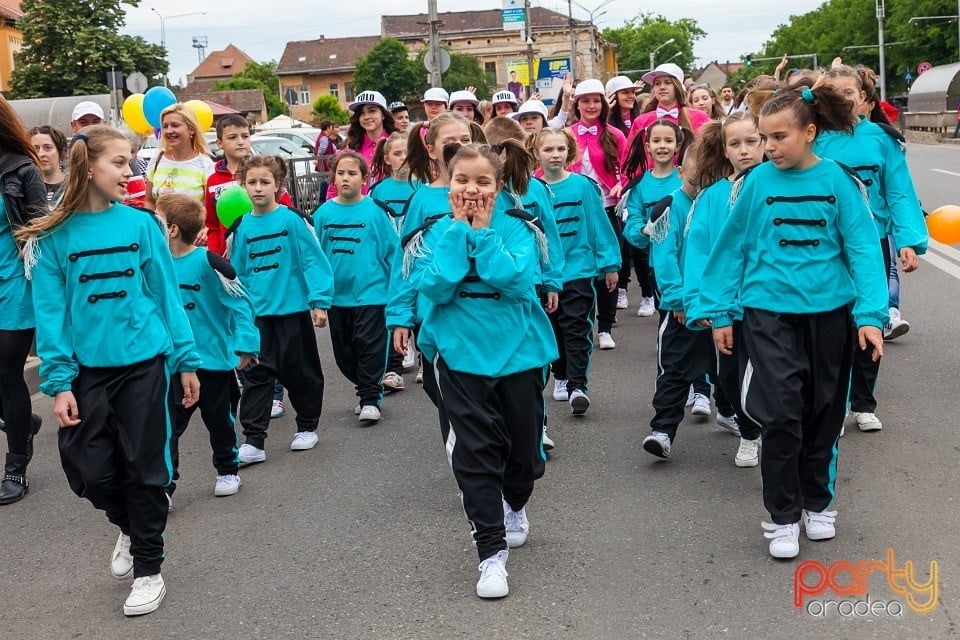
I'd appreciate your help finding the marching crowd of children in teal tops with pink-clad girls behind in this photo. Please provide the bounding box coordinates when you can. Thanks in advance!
[0,58,926,615]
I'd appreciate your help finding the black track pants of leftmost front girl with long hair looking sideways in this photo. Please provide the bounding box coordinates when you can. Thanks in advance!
[59,357,172,578]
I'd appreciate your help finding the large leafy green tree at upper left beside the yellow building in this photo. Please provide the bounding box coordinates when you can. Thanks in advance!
[10,0,169,98]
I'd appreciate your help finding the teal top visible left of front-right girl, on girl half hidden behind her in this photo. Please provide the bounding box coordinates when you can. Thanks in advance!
[683,178,743,330]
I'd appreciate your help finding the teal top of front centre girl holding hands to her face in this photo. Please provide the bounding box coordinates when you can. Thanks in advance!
[410,210,557,377]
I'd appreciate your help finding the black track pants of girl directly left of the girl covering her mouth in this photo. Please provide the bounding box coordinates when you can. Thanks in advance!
[327,305,387,407]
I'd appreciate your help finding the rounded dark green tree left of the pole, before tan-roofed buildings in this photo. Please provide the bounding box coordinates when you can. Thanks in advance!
[353,38,425,103]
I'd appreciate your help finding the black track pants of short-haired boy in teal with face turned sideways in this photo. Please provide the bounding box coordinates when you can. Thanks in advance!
[167,369,240,495]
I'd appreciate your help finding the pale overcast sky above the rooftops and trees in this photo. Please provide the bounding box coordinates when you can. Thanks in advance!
[126,0,824,82]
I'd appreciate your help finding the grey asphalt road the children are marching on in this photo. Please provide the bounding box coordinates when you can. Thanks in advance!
[0,146,960,640]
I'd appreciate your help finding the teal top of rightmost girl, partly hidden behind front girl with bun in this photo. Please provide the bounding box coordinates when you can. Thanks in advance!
[813,116,928,255]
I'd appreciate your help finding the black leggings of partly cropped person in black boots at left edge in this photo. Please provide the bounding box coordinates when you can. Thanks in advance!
[0,328,34,455]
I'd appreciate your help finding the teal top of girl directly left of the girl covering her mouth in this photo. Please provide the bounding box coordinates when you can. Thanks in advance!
[313,197,400,307]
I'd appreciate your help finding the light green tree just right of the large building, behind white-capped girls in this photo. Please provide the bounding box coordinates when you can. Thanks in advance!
[603,13,707,76]
